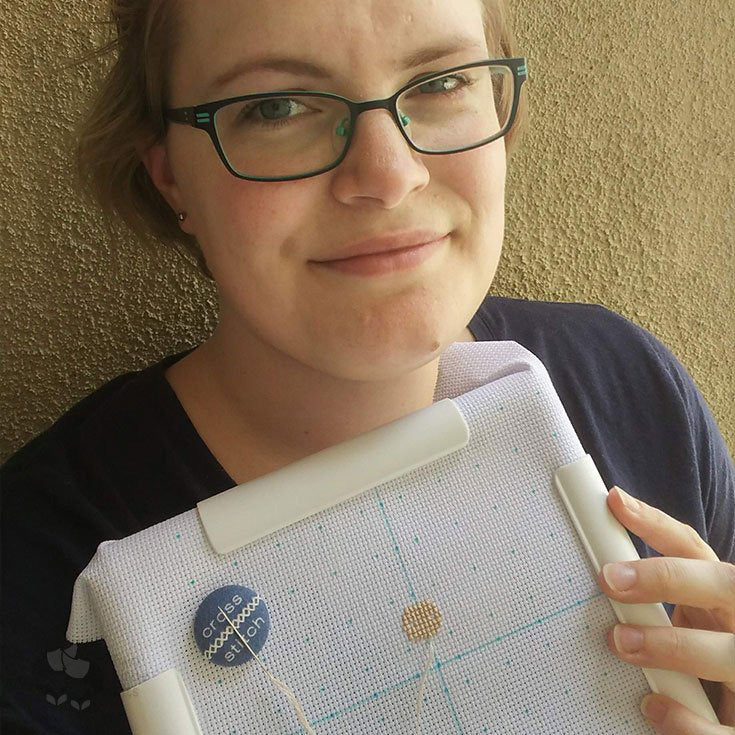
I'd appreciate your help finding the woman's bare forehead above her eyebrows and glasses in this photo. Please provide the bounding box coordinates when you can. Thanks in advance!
[173,0,486,96]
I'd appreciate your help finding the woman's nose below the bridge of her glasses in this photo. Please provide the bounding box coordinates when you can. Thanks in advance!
[332,110,429,209]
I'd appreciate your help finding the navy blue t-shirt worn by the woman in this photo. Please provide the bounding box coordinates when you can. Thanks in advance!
[0,296,735,733]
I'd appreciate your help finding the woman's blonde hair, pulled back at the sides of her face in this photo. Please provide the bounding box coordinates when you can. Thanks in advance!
[63,0,528,279]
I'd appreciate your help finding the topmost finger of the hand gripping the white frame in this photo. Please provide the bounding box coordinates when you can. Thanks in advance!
[607,485,719,561]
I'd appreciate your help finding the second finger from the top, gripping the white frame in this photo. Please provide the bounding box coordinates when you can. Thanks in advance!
[597,556,735,616]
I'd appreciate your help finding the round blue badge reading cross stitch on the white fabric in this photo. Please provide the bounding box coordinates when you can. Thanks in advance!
[194,584,270,666]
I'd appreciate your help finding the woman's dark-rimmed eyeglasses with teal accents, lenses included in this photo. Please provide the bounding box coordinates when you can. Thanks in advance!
[164,58,528,181]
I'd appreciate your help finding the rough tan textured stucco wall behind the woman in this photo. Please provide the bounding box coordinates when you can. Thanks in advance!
[0,0,735,459]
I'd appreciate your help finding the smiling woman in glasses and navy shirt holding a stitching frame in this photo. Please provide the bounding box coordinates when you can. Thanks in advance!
[3,0,735,734]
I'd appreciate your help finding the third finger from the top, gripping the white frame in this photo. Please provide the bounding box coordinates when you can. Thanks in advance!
[607,625,735,686]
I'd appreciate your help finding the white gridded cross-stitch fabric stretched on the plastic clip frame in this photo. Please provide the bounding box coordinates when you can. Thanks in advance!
[67,342,651,735]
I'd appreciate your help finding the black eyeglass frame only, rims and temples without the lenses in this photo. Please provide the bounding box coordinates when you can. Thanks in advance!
[163,57,528,182]
